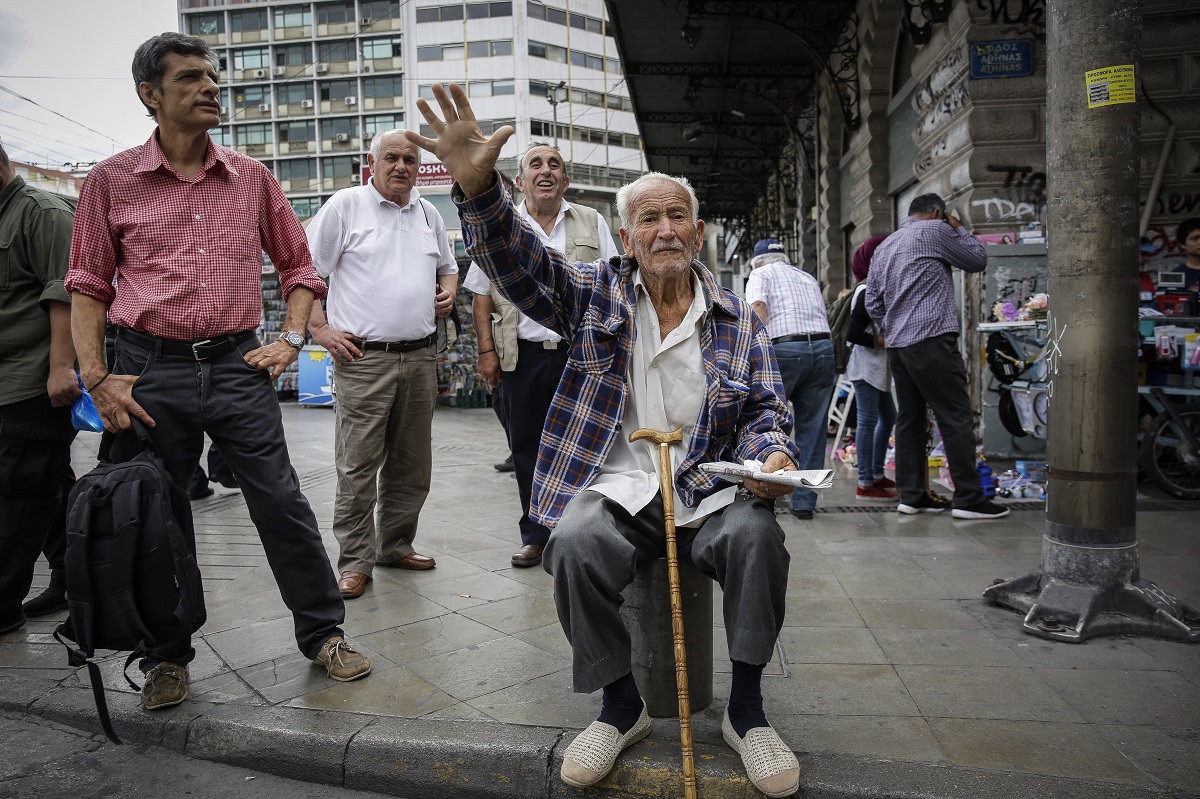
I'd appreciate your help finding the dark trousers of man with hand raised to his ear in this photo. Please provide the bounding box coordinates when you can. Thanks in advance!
[888,334,985,507]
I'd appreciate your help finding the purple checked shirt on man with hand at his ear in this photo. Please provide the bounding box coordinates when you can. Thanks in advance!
[866,216,988,349]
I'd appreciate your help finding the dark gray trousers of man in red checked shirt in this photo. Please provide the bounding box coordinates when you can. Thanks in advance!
[112,334,346,671]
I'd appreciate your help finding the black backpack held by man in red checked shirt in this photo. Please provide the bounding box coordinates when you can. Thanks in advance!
[54,420,206,744]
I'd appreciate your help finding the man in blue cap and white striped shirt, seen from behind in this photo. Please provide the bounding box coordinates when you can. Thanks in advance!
[746,239,838,519]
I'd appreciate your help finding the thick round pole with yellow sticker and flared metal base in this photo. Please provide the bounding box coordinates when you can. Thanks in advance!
[984,0,1200,642]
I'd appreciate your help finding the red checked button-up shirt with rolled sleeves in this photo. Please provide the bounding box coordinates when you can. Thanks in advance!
[66,132,325,340]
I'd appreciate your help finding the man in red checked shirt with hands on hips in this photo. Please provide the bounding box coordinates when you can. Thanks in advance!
[66,32,371,710]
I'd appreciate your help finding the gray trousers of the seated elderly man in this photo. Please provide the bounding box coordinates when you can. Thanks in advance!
[542,491,791,693]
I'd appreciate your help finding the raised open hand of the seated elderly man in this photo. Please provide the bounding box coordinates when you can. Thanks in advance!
[404,83,512,198]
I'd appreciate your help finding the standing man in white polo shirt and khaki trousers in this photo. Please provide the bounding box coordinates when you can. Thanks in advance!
[307,131,458,599]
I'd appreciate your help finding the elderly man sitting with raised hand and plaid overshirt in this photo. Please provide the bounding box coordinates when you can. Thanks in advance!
[407,84,799,797]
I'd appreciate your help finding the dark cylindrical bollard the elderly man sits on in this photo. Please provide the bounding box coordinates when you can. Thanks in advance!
[620,558,713,719]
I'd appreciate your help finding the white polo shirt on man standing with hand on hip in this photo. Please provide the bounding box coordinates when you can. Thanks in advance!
[307,182,458,341]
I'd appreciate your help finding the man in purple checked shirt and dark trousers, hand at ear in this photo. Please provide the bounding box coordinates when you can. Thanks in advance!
[866,194,1008,518]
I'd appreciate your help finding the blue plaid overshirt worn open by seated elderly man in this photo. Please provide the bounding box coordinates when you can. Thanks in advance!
[452,172,799,527]
